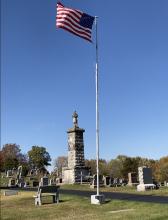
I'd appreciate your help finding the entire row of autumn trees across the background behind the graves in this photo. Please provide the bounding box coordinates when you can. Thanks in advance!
[0,144,168,182]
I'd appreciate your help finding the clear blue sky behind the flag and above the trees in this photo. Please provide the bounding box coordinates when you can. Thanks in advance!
[1,0,168,168]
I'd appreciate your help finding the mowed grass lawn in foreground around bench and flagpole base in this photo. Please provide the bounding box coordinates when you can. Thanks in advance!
[1,189,168,220]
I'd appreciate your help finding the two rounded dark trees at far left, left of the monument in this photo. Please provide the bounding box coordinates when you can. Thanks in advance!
[0,144,51,176]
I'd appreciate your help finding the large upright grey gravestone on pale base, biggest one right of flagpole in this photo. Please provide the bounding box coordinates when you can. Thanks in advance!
[137,167,155,191]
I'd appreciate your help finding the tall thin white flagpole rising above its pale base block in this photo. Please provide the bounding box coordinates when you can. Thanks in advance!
[95,16,99,196]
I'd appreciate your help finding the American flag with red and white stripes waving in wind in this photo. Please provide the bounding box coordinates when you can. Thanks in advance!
[56,2,94,42]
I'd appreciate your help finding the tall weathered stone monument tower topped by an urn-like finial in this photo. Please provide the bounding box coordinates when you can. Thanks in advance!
[62,111,89,184]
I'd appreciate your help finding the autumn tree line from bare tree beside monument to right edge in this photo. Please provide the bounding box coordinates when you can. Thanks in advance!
[54,155,168,182]
